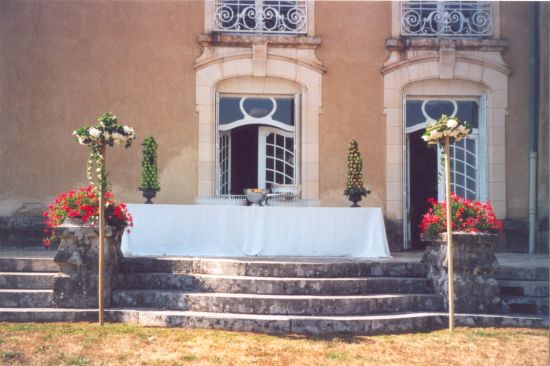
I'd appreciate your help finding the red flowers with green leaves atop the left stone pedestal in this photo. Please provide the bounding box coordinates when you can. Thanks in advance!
[42,185,134,248]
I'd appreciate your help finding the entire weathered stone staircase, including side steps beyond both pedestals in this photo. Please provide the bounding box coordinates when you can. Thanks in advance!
[0,256,548,334]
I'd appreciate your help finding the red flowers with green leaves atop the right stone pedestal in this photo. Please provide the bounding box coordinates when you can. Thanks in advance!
[420,193,502,239]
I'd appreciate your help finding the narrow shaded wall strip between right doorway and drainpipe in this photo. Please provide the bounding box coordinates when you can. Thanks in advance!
[500,2,529,219]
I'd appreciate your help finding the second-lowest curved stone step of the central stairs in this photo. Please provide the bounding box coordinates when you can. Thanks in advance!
[113,290,443,315]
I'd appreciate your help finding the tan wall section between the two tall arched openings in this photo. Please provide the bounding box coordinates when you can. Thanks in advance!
[315,1,391,207]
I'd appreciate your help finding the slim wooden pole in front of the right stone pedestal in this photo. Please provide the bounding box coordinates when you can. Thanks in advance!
[445,136,455,332]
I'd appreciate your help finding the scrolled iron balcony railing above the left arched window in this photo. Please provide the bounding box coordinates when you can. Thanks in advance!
[213,0,307,34]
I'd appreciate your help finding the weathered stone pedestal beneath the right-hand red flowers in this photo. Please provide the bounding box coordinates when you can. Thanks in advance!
[422,233,500,313]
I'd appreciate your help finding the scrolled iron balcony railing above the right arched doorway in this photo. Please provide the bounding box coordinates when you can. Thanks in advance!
[401,1,493,38]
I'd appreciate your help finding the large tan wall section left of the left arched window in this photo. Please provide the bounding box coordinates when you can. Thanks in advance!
[0,0,204,215]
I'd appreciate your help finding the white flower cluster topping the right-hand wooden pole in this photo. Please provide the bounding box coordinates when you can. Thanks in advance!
[422,115,472,145]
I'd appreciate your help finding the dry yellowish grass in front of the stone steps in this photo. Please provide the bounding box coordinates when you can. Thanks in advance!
[0,323,548,366]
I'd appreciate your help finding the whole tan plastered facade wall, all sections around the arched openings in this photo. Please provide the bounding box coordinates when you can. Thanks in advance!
[0,0,528,222]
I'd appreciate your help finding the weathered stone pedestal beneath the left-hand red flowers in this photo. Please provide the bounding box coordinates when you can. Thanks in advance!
[53,221,122,308]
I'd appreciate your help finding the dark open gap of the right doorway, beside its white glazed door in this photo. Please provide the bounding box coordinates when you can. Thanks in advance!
[407,130,437,250]
